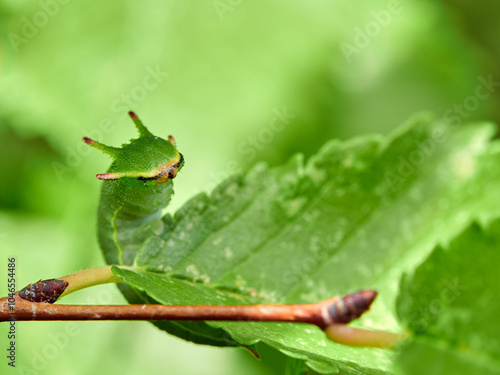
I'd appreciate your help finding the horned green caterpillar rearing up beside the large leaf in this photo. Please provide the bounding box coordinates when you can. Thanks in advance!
[83,112,184,265]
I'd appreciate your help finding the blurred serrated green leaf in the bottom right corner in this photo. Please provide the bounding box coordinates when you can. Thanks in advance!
[397,220,500,375]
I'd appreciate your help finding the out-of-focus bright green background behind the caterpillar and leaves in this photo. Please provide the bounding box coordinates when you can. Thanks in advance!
[0,0,500,375]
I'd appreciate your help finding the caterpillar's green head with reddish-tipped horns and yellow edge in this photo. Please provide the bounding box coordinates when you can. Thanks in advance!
[83,111,184,184]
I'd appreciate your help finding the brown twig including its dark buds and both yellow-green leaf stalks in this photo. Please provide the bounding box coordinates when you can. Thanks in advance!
[0,266,403,348]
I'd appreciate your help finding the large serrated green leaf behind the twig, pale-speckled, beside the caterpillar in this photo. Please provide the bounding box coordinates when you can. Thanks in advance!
[114,116,500,374]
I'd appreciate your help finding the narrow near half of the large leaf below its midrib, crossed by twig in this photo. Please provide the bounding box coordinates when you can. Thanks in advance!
[113,266,389,374]
